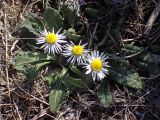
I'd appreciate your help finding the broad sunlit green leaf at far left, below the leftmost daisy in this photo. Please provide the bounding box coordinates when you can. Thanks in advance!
[11,52,55,79]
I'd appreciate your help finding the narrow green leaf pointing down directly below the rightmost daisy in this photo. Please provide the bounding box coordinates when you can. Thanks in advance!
[97,80,112,107]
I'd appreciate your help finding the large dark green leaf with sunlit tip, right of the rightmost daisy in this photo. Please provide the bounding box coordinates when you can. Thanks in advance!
[109,61,143,88]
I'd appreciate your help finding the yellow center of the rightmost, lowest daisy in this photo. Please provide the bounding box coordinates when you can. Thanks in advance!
[91,59,103,71]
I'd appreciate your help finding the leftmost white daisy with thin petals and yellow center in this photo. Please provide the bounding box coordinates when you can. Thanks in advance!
[36,29,66,54]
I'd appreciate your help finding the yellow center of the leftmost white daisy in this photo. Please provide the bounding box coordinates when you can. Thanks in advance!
[46,33,58,44]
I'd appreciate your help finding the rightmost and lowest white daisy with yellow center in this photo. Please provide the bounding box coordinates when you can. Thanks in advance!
[84,51,110,81]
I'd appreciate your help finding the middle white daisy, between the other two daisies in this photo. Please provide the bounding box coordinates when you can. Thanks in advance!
[63,41,89,65]
